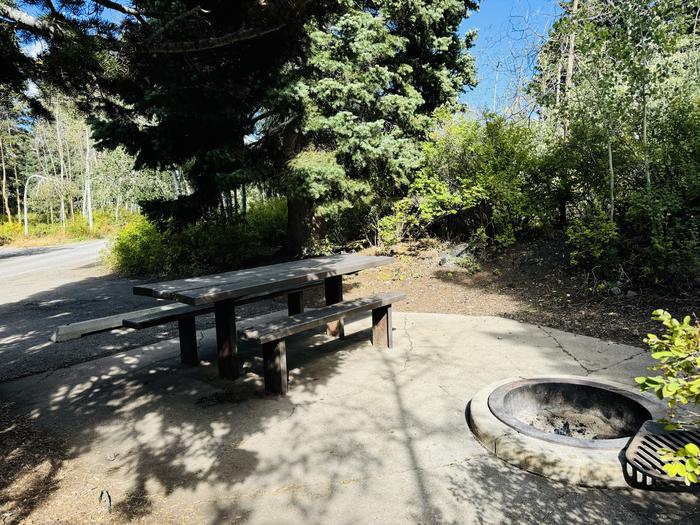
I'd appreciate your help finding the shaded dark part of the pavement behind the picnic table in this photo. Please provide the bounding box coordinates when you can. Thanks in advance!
[0,275,342,382]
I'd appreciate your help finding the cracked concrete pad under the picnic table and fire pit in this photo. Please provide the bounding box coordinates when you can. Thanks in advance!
[0,313,700,524]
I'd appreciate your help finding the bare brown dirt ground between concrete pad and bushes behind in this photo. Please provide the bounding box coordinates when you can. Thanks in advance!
[346,240,700,347]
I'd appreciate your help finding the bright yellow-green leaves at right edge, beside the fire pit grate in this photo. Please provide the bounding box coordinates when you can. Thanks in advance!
[636,310,700,485]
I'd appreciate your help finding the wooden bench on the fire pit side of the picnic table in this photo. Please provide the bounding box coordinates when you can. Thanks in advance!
[244,292,406,394]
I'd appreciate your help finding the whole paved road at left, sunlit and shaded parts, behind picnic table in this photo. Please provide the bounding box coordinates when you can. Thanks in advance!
[0,237,279,382]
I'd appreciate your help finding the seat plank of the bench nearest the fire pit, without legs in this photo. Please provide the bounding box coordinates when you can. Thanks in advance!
[245,292,406,344]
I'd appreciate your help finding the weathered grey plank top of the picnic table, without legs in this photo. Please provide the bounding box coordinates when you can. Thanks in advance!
[134,255,394,305]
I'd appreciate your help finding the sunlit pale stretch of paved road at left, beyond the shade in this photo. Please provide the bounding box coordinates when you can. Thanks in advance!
[0,240,107,280]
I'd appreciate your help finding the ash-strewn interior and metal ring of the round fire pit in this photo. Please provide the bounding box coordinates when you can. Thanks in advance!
[488,379,652,447]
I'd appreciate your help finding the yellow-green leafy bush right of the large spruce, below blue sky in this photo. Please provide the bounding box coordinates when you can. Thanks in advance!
[379,112,536,246]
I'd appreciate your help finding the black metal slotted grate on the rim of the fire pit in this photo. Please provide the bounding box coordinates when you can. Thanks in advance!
[625,421,700,492]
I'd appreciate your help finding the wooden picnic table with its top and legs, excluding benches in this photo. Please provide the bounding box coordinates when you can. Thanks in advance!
[134,255,393,379]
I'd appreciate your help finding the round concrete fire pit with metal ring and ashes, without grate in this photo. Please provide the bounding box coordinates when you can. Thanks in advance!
[468,376,662,487]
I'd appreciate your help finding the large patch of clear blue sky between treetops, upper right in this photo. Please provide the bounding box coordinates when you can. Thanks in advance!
[460,0,561,109]
